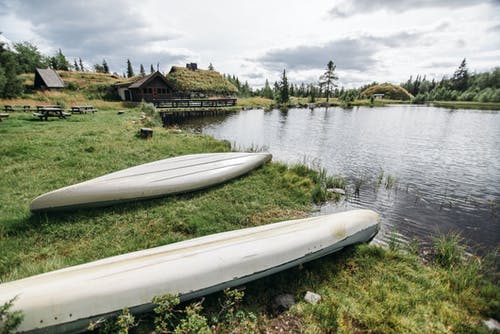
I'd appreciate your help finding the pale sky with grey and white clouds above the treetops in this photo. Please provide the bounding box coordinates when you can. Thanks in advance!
[0,0,500,87]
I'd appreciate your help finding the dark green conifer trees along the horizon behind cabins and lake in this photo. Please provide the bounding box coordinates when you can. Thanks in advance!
[0,33,500,104]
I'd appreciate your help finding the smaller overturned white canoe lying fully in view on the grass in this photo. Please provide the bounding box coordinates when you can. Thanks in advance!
[30,153,272,211]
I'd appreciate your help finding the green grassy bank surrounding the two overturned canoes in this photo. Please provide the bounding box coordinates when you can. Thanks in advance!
[0,103,500,333]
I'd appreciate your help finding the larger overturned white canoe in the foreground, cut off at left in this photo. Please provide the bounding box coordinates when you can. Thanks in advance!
[0,210,379,333]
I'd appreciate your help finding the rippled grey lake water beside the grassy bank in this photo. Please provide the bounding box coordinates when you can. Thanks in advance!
[184,105,500,253]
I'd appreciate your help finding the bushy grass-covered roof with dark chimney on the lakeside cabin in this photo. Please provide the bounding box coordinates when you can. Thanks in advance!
[165,63,238,98]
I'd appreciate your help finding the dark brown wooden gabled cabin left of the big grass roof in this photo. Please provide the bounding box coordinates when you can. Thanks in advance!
[119,71,174,102]
